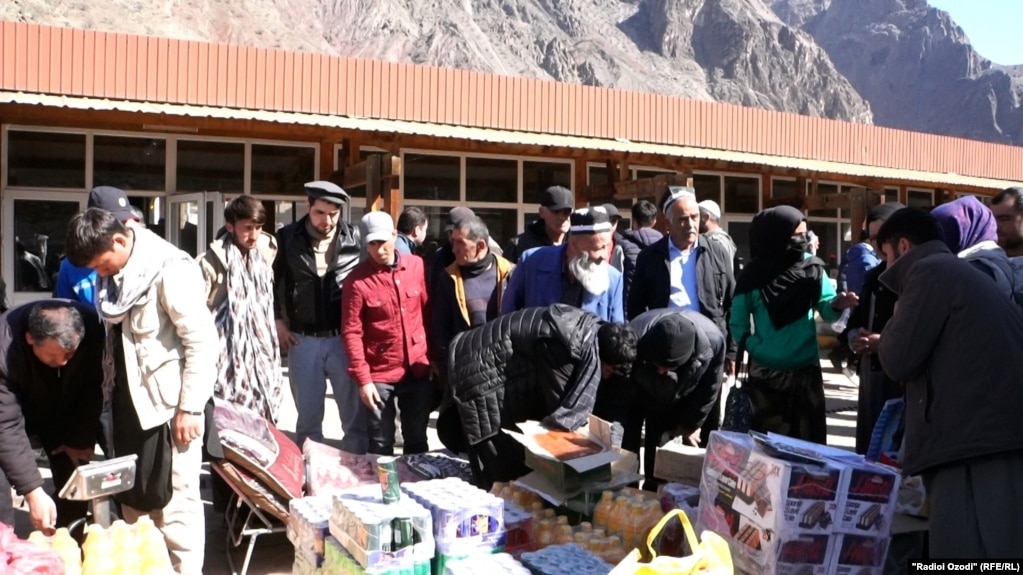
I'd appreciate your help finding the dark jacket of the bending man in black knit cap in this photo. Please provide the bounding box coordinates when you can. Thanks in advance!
[631,309,727,430]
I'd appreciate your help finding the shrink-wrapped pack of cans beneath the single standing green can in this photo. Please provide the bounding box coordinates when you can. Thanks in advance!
[331,485,435,575]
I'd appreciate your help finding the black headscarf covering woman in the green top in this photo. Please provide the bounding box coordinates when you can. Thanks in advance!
[736,206,825,327]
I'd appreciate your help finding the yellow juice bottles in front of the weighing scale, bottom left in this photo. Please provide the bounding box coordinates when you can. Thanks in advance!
[82,517,174,575]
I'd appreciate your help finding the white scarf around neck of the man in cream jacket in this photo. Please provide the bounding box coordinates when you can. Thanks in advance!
[96,226,191,401]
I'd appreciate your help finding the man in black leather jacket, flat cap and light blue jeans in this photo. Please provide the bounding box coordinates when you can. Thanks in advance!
[273,181,369,453]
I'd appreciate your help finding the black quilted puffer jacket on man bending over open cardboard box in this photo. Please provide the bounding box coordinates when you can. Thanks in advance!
[448,304,601,445]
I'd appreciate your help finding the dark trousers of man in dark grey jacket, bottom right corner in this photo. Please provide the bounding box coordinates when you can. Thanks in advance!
[924,451,1023,560]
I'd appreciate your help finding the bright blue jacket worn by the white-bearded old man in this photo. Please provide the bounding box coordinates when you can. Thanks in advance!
[501,245,625,323]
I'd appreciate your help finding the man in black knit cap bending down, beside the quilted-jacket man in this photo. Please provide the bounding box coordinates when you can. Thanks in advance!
[593,309,727,491]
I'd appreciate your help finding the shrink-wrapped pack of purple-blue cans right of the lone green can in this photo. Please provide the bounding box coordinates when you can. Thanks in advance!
[401,478,506,573]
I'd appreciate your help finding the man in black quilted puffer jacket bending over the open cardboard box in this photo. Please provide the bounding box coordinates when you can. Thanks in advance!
[448,304,636,488]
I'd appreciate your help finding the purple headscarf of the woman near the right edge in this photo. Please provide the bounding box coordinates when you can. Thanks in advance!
[931,195,1015,297]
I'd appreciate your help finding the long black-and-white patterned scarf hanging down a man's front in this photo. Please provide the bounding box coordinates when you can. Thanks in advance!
[213,234,281,423]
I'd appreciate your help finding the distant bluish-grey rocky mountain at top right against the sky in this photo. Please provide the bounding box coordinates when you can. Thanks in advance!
[771,0,1023,145]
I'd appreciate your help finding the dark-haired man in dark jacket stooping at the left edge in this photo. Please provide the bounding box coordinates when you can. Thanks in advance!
[0,300,104,531]
